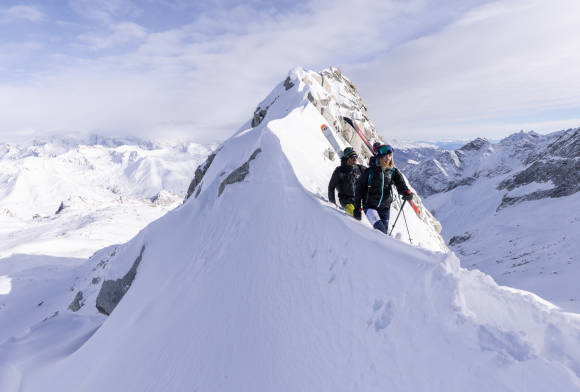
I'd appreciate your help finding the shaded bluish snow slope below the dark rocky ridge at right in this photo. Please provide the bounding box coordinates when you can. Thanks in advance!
[425,179,580,313]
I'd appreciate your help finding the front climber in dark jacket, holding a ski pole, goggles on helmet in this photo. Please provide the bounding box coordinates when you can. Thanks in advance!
[353,146,413,235]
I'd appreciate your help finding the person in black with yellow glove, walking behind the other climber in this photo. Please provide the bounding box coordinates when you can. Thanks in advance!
[328,147,365,215]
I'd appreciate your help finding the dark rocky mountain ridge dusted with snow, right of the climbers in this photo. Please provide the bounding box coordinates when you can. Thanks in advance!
[408,128,580,202]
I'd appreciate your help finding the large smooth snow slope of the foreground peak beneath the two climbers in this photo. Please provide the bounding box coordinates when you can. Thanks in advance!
[0,70,580,392]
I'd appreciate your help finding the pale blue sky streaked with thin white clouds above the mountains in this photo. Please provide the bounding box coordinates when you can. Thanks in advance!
[0,0,580,141]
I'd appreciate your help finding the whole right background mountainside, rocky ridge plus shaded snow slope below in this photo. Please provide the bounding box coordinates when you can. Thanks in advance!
[408,129,580,313]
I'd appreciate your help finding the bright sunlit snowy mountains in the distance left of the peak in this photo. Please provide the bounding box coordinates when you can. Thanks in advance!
[0,137,209,258]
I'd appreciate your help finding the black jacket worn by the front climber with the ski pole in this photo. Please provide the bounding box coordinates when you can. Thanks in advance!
[354,166,409,210]
